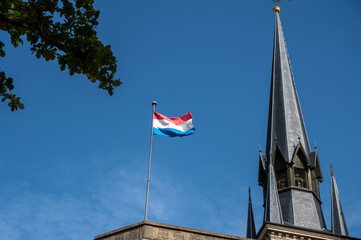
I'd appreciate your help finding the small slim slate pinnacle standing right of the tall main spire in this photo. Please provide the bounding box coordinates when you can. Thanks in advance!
[331,164,348,236]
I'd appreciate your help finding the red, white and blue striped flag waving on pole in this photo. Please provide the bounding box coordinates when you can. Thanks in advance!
[153,112,196,137]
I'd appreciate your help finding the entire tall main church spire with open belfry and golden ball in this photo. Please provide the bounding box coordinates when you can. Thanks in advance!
[258,6,326,230]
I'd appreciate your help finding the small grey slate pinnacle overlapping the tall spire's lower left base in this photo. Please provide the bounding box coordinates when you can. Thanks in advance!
[264,164,283,224]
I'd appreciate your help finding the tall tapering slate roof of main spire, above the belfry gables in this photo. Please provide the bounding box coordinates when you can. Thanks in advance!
[266,13,310,162]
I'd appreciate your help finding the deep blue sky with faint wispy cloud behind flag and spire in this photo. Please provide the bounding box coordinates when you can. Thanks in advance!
[0,0,361,240]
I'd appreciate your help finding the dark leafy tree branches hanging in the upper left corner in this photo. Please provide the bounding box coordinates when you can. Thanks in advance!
[0,0,121,111]
